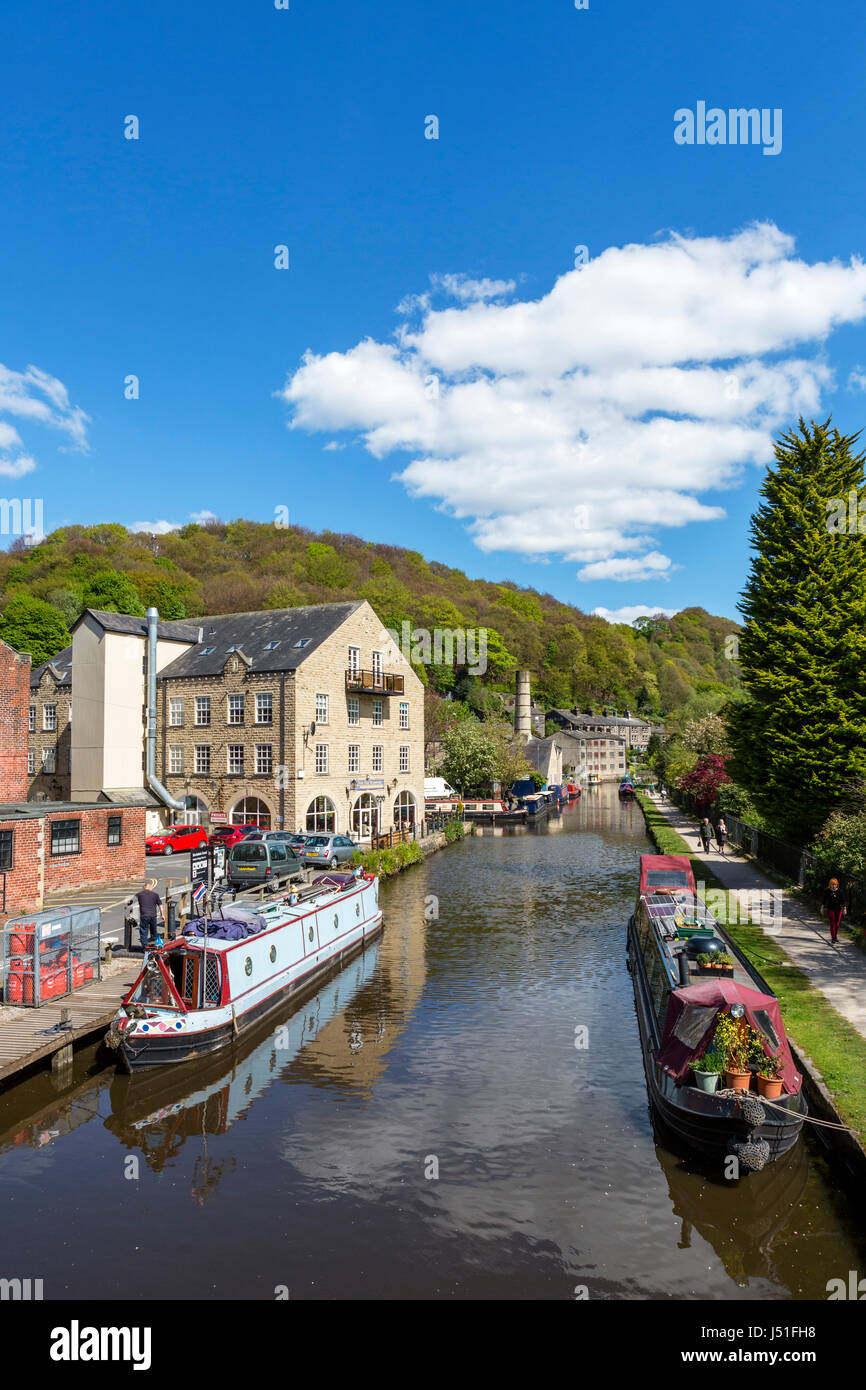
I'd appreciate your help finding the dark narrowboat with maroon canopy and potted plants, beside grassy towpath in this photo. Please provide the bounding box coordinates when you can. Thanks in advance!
[627,855,806,1172]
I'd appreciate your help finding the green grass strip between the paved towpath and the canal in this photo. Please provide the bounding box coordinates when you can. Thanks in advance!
[637,792,866,1144]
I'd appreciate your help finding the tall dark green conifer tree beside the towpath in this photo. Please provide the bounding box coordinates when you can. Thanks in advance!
[731,420,866,838]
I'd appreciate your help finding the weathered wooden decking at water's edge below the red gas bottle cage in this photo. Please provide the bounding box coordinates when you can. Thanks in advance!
[0,959,140,1086]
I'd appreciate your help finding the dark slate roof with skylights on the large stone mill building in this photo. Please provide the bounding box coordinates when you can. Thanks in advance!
[160,600,363,680]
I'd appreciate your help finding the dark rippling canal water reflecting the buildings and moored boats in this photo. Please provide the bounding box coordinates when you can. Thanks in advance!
[0,787,866,1300]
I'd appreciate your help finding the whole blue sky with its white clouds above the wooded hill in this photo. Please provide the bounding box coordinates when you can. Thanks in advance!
[0,0,866,616]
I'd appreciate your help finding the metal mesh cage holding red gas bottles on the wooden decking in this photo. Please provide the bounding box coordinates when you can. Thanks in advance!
[0,908,101,1008]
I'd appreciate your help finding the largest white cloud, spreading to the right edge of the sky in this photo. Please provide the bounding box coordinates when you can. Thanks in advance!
[279,224,866,580]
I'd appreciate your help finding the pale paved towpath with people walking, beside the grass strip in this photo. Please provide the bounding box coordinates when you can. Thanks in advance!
[651,796,866,1037]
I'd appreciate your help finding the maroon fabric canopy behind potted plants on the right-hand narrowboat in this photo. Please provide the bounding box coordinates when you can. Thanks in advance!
[661,978,802,1095]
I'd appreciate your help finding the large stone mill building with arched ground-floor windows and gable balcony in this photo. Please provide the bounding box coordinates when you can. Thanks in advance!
[157,602,424,838]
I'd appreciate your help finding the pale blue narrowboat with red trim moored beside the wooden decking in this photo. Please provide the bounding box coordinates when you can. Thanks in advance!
[106,870,382,1072]
